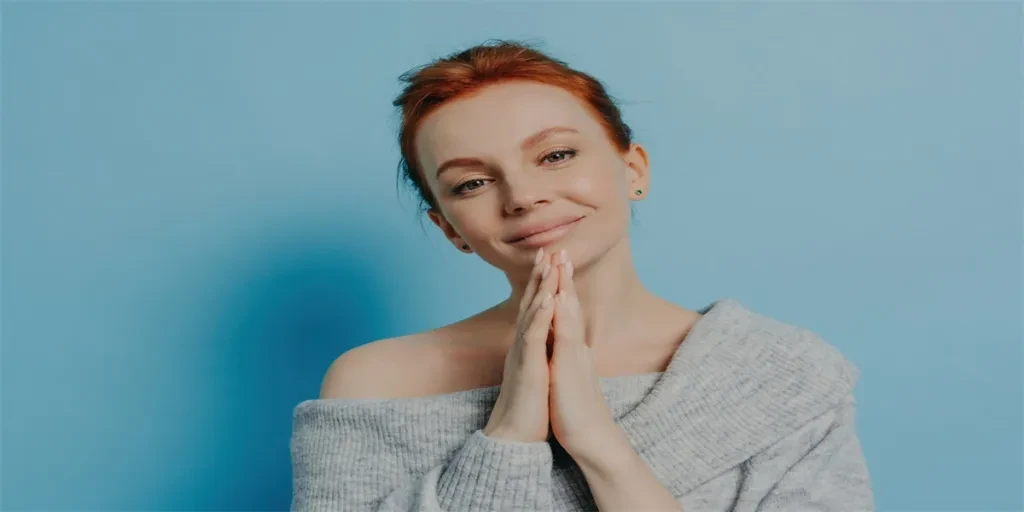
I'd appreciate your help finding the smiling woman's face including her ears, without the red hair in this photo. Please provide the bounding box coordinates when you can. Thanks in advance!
[416,82,648,272]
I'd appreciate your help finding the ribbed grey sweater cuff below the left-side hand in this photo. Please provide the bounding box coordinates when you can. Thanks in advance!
[437,430,552,510]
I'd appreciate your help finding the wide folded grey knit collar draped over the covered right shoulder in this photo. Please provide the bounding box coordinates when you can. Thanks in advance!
[616,299,858,496]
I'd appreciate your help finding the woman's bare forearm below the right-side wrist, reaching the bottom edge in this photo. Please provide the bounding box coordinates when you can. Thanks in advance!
[575,435,682,511]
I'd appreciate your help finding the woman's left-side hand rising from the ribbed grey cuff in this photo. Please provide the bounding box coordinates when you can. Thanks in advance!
[483,250,558,442]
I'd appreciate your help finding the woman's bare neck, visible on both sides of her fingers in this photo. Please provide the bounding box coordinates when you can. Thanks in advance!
[498,239,659,346]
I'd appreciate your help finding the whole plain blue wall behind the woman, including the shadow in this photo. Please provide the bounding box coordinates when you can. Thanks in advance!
[2,2,1024,510]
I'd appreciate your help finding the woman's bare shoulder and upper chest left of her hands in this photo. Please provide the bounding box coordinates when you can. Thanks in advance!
[321,325,504,398]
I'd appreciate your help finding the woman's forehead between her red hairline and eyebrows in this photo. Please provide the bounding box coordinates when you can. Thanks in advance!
[416,82,603,169]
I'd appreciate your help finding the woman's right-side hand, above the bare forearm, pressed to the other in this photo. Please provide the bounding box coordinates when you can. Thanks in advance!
[549,250,621,461]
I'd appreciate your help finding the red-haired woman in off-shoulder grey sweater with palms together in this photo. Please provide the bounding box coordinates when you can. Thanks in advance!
[292,42,873,511]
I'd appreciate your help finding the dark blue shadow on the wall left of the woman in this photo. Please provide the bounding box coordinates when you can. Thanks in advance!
[165,230,393,510]
